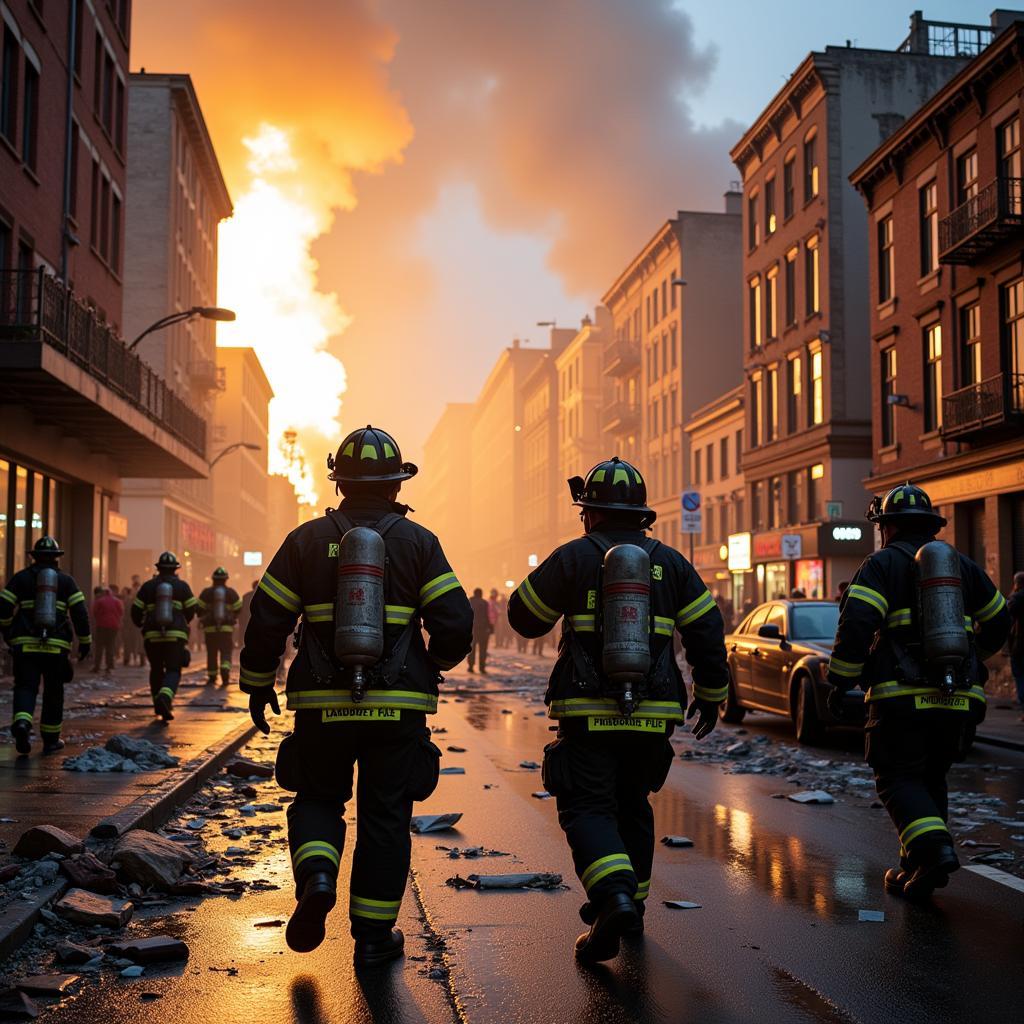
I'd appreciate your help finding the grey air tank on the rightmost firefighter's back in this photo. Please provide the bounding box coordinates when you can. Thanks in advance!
[914,541,970,693]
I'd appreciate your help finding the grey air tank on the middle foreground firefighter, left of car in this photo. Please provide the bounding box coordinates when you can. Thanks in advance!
[601,544,650,717]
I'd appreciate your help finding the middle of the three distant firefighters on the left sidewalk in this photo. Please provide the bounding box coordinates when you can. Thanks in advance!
[131,551,199,722]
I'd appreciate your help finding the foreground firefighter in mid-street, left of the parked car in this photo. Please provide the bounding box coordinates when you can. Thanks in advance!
[508,458,728,964]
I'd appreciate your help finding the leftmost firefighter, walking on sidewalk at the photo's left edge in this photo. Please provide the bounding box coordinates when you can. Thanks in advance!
[0,537,92,755]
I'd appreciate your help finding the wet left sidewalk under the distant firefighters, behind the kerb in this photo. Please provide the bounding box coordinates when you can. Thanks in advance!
[0,662,247,866]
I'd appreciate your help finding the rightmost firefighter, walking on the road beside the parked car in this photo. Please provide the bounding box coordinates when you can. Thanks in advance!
[828,482,1009,899]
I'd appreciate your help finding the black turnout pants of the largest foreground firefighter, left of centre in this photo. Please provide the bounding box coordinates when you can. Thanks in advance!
[276,709,440,938]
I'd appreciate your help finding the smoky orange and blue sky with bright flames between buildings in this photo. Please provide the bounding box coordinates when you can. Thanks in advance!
[132,0,1003,498]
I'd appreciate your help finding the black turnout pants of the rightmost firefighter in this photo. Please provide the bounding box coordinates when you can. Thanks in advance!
[864,708,974,868]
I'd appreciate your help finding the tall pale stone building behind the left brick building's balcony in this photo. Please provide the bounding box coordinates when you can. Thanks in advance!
[123,74,237,579]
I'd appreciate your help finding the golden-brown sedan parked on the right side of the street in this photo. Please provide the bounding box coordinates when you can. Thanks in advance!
[721,600,864,743]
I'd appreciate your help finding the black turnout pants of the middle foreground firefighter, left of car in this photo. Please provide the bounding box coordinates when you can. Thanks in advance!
[544,719,673,912]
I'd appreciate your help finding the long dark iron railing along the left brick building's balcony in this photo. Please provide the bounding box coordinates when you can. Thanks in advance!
[0,267,206,458]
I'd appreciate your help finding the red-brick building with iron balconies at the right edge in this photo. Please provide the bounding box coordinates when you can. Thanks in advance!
[851,11,1024,590]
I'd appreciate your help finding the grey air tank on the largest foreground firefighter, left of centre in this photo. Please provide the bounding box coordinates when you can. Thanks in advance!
[334,526,384,703]
